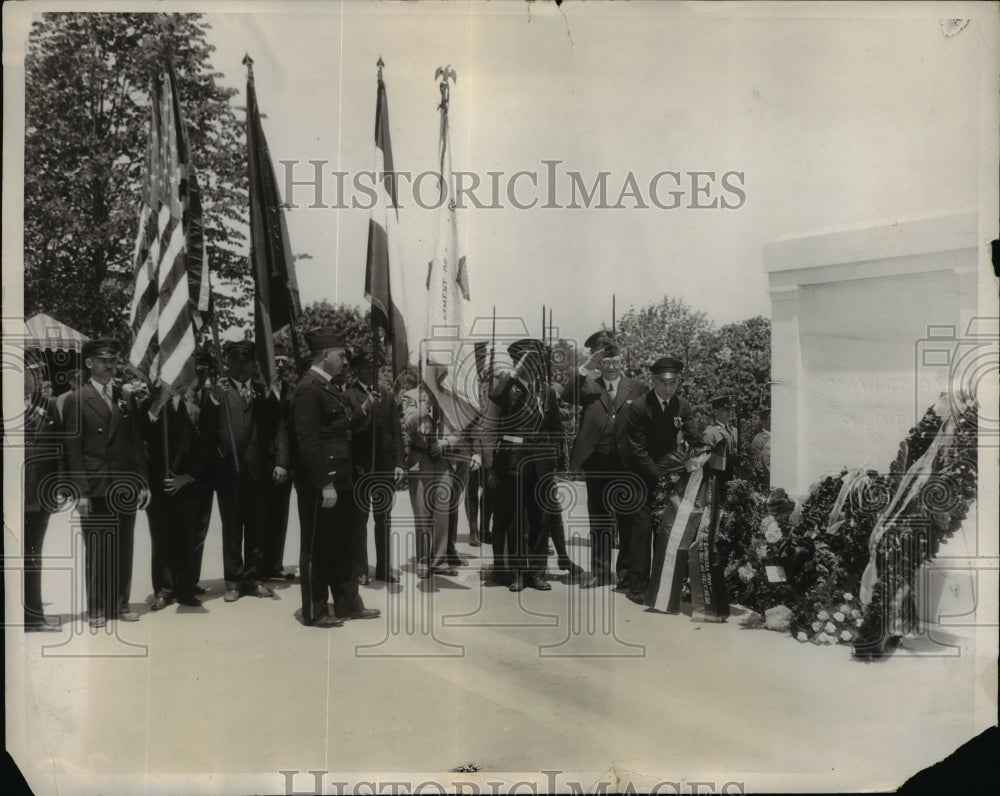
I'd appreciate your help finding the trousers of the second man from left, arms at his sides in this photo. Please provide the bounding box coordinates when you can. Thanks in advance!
[80,497,135,619]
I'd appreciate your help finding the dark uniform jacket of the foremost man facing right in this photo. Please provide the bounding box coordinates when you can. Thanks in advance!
[286,371,359,492]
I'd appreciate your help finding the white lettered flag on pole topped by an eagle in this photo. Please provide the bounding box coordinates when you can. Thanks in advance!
[421,69,480,430]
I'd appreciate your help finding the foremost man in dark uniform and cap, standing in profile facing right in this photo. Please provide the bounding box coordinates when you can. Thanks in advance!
[277,328,379,628]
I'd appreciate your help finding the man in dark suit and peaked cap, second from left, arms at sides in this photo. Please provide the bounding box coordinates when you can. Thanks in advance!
[63,339,149,627]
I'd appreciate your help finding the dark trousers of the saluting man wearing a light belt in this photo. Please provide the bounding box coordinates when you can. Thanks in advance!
[493,468,551,578]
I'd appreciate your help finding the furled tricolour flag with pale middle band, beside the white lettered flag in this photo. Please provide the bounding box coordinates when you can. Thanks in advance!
[365,58,410,376]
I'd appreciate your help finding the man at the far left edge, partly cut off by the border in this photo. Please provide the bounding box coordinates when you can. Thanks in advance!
[23,355,62,633]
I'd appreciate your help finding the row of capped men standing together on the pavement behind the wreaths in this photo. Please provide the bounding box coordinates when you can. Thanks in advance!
[25,327,752,630]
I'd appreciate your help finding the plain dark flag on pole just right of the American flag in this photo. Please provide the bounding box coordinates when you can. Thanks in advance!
[243,55,302,383]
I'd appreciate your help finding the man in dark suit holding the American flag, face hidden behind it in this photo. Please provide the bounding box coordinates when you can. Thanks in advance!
[142,386,212,611]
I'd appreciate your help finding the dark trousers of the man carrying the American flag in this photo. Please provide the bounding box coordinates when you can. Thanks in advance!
[146,484,202,601]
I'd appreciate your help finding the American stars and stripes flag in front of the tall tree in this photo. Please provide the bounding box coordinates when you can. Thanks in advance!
[129,62,200,414]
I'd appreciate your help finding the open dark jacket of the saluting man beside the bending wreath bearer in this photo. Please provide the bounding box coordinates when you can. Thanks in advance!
[562,374,647,471]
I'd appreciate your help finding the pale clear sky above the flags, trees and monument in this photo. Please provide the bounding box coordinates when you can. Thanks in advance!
[1,2,984,349]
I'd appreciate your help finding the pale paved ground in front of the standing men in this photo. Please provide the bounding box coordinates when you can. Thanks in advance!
[7,482,996,793]
